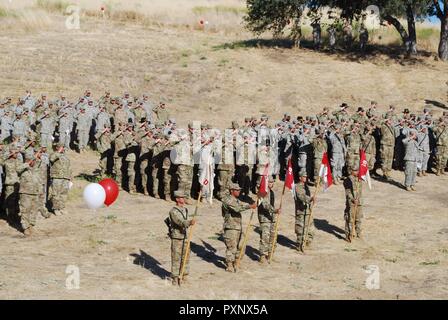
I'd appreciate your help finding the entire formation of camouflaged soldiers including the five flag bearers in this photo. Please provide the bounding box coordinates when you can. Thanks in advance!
[0,90,448,282]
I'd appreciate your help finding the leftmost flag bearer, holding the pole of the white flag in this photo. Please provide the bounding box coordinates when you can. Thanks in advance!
[169,190,196,285]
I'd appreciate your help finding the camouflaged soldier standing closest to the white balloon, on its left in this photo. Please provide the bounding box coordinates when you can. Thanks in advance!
[49,144,72,216]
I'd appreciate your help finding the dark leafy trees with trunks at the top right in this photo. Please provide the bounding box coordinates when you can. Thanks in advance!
[245,0,448,61]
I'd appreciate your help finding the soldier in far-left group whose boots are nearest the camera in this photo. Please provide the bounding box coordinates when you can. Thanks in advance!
[18,154,41,236]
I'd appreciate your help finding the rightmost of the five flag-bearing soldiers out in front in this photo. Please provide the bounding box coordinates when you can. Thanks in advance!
[344,166,363,242]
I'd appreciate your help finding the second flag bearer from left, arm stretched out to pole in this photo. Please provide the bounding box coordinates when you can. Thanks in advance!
[222,183,257,272]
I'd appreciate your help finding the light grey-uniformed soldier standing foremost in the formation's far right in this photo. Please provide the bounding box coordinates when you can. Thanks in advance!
[403,130,419,191]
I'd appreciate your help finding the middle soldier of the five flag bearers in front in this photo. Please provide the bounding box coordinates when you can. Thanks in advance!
[258,178,280,264]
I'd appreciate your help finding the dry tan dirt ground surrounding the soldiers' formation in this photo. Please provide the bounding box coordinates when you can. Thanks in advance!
[0,12,448,299]
